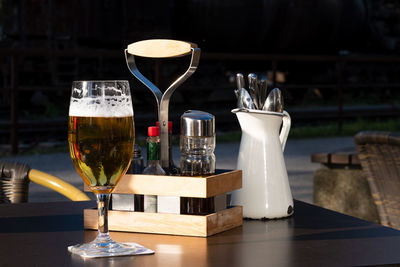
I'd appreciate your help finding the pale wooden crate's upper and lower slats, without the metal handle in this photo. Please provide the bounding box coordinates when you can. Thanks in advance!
[84,170,243,237]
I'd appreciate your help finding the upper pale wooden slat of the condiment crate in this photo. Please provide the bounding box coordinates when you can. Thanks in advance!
[85,170,242,198]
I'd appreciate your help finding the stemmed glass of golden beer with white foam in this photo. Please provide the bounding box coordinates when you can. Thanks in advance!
[68,81,137,257]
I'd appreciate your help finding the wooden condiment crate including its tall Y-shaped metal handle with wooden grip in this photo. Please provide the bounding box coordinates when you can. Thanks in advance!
[84,39,243,237]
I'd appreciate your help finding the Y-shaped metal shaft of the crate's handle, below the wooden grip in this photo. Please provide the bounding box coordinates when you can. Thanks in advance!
[125,45,201,168]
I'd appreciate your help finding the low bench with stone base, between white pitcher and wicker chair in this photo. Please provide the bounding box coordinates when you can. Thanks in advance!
[311,151,379,223]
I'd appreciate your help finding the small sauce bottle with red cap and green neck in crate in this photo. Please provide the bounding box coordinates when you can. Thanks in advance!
[143,127,165,212]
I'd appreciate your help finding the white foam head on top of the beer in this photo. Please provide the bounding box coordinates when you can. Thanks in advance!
[69,82,133,117]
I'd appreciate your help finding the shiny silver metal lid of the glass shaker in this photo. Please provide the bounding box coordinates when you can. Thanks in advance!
[181,110,215,136]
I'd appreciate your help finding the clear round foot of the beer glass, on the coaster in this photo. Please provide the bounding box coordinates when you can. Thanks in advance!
[68,235,142,258]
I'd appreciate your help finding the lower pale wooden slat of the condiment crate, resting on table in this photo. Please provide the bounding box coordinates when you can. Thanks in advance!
[84,206,243,237]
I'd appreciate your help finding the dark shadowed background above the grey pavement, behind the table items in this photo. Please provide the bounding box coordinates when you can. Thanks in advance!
[0,0,400,154]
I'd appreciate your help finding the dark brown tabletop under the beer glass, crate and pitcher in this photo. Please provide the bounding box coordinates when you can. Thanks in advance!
[0,201,400,266]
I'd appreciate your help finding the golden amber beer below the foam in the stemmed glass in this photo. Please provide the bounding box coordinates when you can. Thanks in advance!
[68,116,135,193]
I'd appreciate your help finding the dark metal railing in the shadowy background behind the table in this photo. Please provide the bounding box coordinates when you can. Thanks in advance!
[0,48,400,154]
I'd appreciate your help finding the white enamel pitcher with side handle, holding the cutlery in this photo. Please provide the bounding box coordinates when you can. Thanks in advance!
[231,109,293,219]
